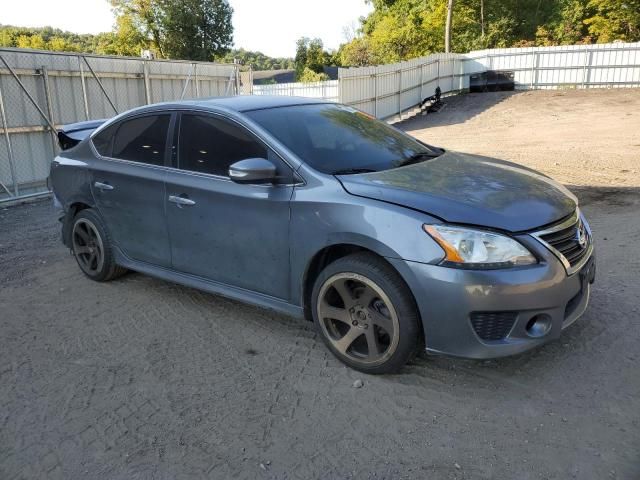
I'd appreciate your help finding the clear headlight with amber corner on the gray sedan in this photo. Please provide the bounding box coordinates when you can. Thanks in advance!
[422,225,537,269]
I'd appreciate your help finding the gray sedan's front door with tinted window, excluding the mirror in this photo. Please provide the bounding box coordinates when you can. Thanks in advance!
[166,113,293,299]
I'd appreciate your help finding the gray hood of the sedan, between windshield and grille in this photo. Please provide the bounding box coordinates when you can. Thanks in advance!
[337,152,578,232]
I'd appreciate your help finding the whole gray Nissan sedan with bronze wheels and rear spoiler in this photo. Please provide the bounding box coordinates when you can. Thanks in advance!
[50,96,595,373]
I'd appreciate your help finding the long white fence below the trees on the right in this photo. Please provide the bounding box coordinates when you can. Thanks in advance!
[338,43,640,118]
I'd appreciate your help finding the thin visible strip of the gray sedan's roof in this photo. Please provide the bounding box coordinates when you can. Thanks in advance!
[143,95,333,112]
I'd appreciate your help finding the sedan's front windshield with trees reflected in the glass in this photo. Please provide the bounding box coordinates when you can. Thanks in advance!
[246,104,442,174]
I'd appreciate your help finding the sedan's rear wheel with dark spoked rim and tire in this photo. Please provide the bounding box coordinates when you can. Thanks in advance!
[71,208,127,282]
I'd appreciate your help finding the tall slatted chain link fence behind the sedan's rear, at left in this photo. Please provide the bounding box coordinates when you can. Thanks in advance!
[0,48,239,203]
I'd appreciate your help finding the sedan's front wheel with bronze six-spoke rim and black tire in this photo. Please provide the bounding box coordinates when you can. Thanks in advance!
[311,252,423,374]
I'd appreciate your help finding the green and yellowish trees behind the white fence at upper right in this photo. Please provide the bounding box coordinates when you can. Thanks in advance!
[340,0,640,65]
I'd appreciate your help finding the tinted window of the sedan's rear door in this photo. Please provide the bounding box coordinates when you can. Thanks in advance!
[110,115,171,165]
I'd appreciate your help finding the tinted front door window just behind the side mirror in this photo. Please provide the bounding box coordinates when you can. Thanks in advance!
[178,114,268,177]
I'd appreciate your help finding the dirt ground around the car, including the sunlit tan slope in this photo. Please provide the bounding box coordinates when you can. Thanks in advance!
[0,90,640,480]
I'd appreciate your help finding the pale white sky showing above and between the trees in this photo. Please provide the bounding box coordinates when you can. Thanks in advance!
[0,0,372,57]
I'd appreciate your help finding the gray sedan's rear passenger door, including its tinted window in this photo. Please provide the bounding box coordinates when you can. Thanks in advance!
[91,113,175,267]
